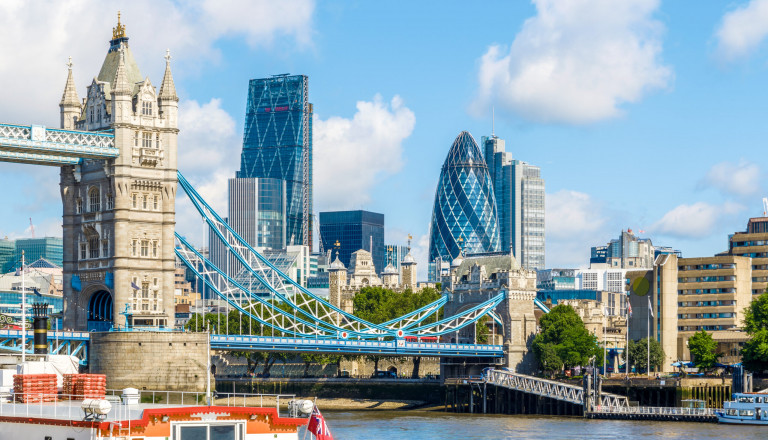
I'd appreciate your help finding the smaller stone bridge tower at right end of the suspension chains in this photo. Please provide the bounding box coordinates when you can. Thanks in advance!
[442,253,536,373]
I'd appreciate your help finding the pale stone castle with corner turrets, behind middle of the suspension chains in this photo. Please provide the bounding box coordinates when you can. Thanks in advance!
[328,249,428,313]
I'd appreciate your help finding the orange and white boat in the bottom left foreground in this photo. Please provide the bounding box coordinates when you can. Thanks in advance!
[0,375,315,440]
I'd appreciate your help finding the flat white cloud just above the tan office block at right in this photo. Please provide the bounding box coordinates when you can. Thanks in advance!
[651,202,744,238]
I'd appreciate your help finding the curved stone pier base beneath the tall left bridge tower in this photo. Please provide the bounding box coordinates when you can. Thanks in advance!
[89,332,208,391]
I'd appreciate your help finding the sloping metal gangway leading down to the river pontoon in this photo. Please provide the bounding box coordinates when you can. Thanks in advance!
[483,369,629,408]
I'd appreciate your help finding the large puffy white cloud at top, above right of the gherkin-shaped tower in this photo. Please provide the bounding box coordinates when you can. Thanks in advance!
[472,0,673,124]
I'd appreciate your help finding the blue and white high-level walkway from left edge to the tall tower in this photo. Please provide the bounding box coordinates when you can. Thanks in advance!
[0,124,120,166]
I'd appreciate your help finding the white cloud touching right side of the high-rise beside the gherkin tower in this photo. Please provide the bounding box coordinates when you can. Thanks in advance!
[546,190,607,267]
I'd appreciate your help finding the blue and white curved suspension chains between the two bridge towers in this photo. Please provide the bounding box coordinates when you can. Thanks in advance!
[176,173,506,339]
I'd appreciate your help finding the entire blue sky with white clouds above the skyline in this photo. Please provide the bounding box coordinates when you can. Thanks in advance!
[0,0,768,278]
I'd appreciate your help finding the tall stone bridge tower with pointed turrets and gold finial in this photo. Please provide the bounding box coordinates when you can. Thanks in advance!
[60,15,179,330]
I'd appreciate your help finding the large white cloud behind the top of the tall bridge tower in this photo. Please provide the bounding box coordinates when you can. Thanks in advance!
[0,0,314,126]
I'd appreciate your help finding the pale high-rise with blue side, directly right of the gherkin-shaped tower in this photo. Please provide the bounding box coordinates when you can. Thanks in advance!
[482,135,545,270]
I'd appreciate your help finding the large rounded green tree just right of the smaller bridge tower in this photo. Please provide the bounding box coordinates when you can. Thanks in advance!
[533,304,598,369]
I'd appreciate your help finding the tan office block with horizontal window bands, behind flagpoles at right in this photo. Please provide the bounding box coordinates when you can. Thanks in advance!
[627,254,753,371]
